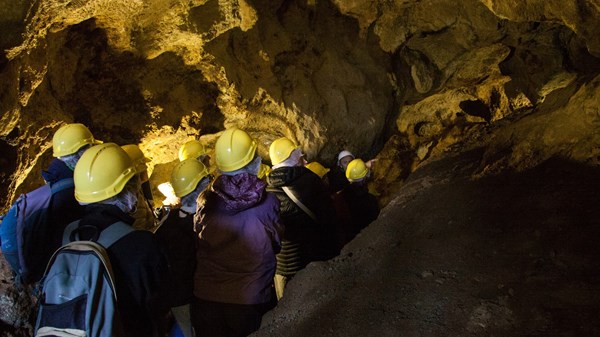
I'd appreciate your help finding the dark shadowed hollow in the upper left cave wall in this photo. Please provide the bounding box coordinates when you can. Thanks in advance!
[55,19,224,144]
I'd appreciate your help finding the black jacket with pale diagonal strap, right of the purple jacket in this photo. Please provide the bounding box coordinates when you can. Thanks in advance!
[267,166,337,277]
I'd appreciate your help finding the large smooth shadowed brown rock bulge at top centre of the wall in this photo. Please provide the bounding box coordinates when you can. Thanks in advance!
[199,1,398,159]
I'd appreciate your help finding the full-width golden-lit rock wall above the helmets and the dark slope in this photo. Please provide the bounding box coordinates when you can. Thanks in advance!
[0,0,600,207]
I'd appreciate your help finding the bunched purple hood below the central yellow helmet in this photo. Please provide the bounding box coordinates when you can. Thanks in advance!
[205,173,266,213]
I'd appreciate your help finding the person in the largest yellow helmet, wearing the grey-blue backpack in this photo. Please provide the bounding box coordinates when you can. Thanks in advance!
[74,143,168,336]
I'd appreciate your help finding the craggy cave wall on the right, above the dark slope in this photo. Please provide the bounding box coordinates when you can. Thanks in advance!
[336,0,600,201]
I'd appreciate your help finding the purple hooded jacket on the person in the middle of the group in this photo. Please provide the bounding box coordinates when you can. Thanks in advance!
[194,173,282,304]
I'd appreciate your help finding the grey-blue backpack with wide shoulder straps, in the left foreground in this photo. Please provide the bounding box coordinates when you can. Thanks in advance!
[34,221,134,337]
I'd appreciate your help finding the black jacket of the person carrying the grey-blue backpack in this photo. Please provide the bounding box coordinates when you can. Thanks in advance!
[79,204,169,336]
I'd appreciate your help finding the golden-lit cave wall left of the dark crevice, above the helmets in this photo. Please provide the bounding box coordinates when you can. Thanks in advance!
[0,1,394,205]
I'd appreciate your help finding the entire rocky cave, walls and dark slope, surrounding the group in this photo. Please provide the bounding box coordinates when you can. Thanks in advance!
[0,0,600,336]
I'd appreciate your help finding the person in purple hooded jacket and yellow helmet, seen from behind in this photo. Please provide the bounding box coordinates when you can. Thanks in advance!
[191,128,282,337]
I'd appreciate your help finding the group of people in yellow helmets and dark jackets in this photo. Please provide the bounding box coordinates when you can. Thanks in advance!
[27,123,379,337]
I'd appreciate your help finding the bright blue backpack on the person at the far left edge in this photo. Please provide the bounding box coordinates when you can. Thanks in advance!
[0,178,74,284]
